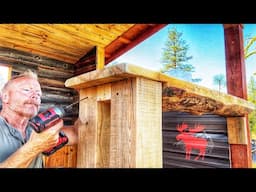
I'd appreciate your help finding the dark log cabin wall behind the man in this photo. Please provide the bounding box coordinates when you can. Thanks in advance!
[0,47,78,167]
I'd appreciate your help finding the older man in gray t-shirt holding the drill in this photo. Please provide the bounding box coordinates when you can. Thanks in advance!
[0,70,77,168]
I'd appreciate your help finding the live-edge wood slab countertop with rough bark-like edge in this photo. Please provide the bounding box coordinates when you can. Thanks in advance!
[65,63,255,117]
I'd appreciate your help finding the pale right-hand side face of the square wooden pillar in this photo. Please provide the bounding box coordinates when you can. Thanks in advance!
[135,77,163,168]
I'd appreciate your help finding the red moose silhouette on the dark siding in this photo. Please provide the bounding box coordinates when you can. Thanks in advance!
[176,123,208,160]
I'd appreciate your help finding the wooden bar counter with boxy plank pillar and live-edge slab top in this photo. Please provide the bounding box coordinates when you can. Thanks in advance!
[65,64,255,168]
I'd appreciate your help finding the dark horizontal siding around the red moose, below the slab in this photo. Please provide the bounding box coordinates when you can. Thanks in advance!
[162,112,230,168]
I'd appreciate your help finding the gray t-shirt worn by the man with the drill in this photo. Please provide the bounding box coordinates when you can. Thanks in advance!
[0,116,43,168]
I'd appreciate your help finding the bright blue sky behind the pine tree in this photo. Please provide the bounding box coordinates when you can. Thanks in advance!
[113,24,256,89]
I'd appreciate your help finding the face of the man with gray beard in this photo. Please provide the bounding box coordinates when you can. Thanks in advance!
[6,77,42,118]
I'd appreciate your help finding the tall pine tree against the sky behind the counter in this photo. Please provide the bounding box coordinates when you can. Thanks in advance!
[160,27,200,82]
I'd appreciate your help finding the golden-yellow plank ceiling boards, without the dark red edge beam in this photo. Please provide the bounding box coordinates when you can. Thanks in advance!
[0,24,134,63]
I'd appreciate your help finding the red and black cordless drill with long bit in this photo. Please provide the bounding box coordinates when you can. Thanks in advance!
[30,97,87,156]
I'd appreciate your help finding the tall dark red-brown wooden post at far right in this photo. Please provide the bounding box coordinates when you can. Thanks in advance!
[224,24,252,168]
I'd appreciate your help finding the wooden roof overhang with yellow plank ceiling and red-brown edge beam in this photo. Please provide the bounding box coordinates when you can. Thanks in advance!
[0,24,167,75]
